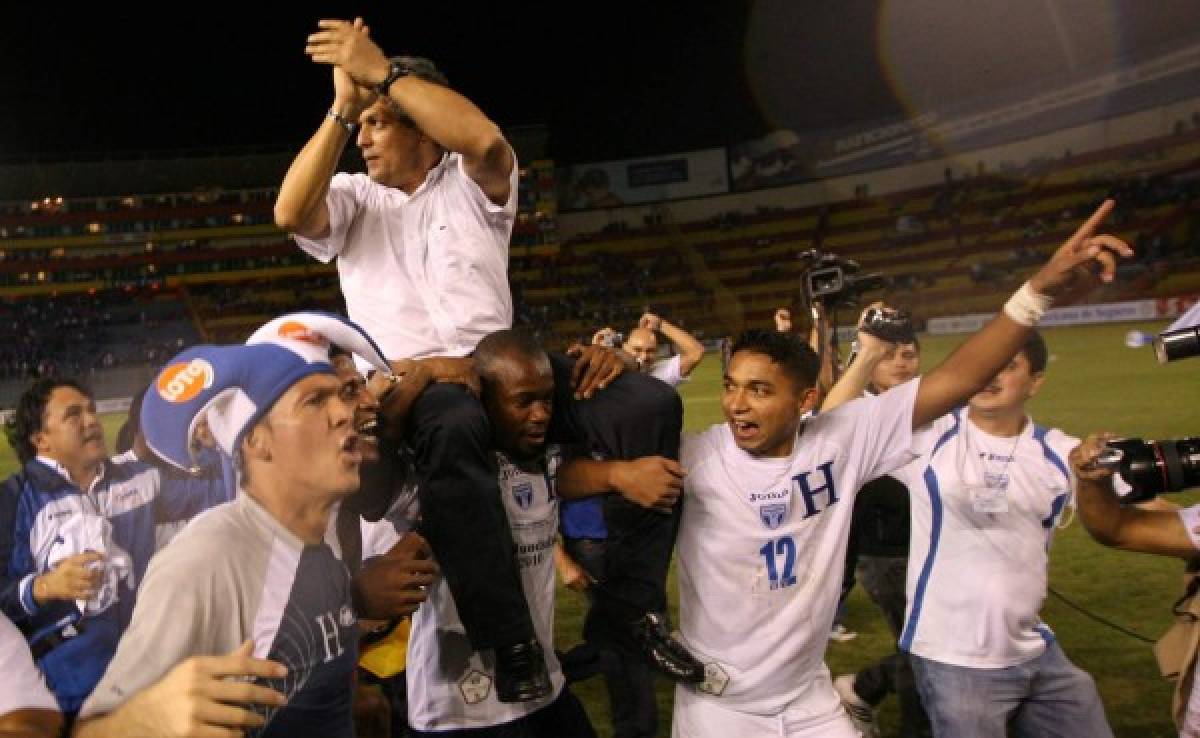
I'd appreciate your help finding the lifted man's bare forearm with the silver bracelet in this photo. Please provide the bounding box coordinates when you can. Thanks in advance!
[275,20,376,239]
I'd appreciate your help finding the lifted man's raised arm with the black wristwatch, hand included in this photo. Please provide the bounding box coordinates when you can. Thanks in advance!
[305,20,516,205]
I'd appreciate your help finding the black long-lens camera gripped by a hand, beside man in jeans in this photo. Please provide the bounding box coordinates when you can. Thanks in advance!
[1096,437,1200,505]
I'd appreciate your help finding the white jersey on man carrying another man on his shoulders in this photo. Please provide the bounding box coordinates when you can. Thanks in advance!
[407,446,563,731]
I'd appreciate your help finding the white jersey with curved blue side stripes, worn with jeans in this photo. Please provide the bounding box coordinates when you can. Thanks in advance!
[893,408,1079,668]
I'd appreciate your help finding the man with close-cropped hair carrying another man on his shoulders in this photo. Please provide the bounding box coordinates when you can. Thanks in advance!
[408,330,682,738]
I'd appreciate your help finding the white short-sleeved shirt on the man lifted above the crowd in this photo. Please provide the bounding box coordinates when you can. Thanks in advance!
[296,154,518,359]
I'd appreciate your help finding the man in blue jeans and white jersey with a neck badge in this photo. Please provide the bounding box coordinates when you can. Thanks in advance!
[893,332,1112,738]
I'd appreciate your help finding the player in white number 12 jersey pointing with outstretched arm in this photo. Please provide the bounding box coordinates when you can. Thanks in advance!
[672,200,1132,738]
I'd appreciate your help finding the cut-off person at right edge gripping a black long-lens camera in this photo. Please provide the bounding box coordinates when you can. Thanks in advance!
[1070,433,1200,738]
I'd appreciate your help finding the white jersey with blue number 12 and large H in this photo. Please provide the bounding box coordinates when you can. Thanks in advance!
[676,380,918,732]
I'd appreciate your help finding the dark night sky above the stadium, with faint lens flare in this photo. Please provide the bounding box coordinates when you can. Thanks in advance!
[7,0,1200,162]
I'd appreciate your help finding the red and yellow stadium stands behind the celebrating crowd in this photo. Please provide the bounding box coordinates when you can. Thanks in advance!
[0,132,1200,396]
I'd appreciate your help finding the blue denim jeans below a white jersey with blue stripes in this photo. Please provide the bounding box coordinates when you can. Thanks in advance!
[912,643,1112,738]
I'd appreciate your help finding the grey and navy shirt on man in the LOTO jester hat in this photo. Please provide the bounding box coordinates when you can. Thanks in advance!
[82,493,359,738]
